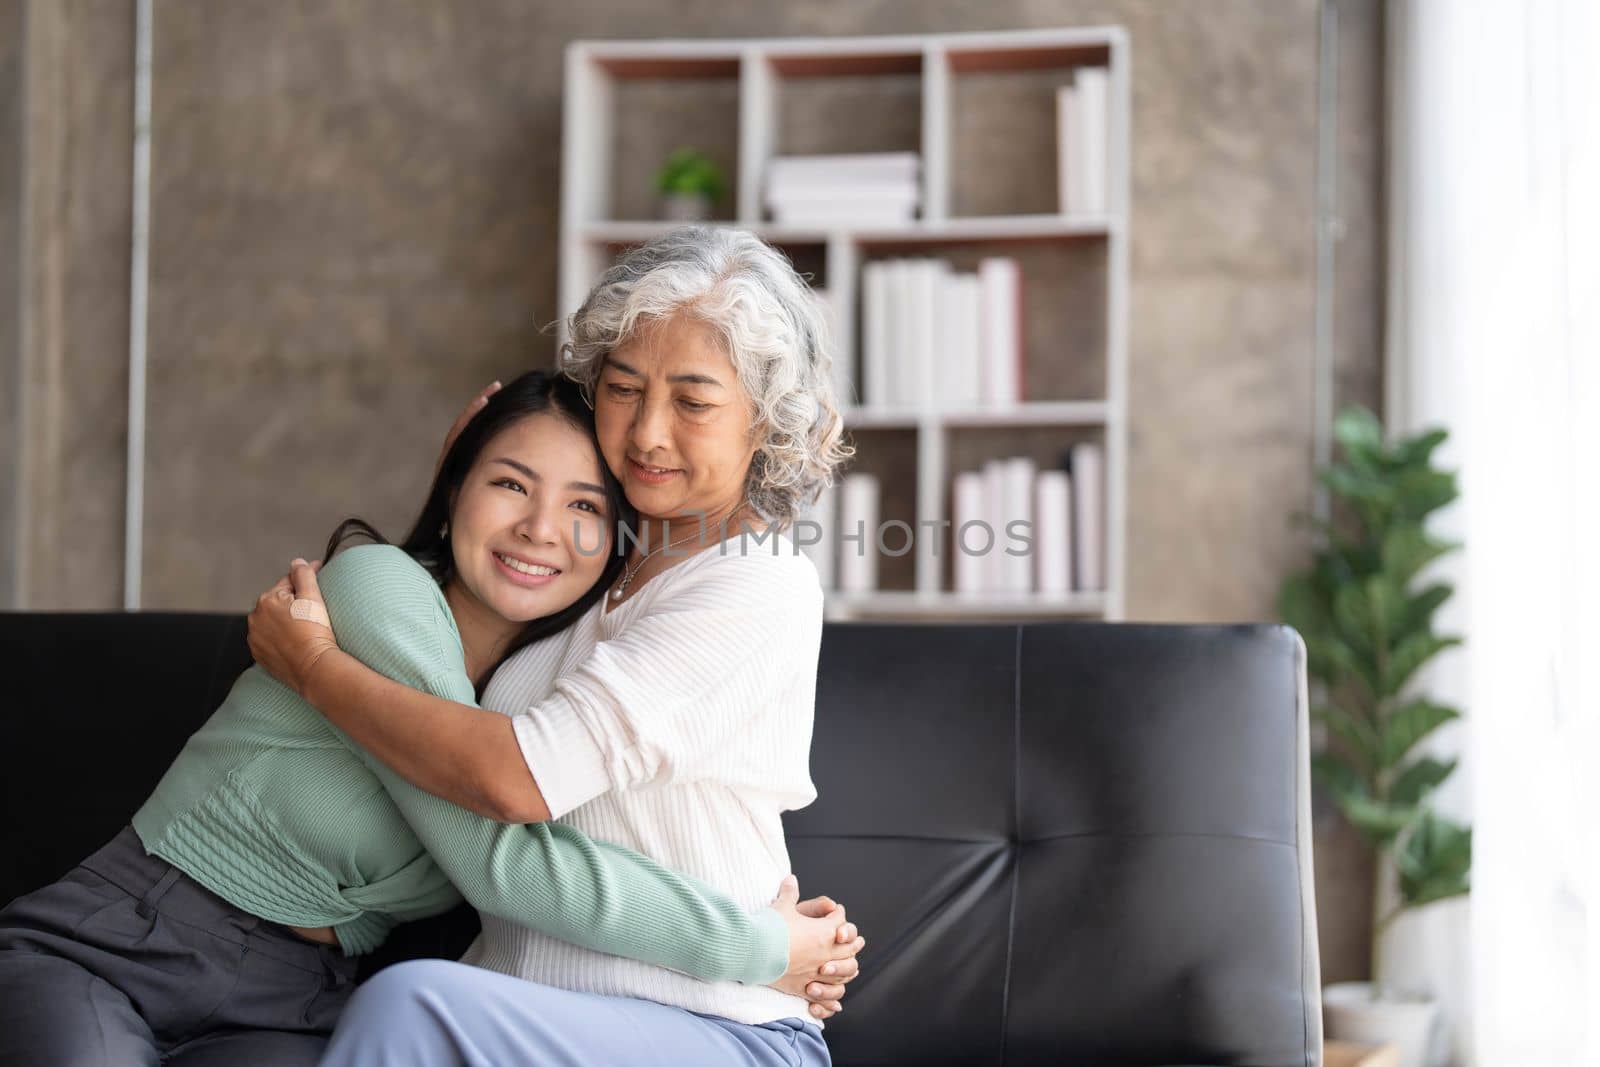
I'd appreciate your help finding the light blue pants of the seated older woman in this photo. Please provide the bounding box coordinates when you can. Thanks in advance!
[322,960,830,1067]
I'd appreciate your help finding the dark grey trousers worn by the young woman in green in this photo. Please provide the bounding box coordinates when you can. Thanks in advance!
[0,827,357,1067]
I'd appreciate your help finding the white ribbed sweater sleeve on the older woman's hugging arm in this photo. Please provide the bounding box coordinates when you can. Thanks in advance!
[512,552,822,817]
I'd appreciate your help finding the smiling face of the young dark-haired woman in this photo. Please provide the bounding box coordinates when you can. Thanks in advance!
[445,414,613,625]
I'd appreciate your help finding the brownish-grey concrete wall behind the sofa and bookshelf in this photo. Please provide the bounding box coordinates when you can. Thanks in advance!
[0,0,1382,979]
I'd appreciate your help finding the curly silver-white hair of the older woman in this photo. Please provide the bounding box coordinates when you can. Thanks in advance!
[558,226,854,530]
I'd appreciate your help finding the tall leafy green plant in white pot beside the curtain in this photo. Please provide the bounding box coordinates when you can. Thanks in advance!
[1278,406,1472,1067]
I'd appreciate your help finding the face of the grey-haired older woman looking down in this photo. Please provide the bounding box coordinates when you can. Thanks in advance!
[595,308,755,522]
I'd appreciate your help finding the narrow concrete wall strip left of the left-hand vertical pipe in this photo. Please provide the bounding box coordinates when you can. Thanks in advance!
[0,0,132,608]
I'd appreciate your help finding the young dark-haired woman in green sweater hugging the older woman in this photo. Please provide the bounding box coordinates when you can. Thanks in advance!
[0,374,851,1065]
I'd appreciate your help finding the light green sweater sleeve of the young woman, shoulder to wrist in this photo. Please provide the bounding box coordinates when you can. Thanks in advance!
[320,545,789,984]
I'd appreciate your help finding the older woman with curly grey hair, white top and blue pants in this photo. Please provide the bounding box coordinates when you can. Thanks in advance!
[251,227,864,1064]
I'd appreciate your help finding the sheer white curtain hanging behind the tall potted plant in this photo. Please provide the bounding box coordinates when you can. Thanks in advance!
[1386,0,1600,1067]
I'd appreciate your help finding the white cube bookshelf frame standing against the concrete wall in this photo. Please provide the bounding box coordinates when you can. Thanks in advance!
[560,26,1130,619]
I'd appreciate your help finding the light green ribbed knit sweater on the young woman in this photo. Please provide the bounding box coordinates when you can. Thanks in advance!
[133,545,789,984]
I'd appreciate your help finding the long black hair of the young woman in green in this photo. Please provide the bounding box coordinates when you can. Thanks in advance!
[322,371,635,696]
